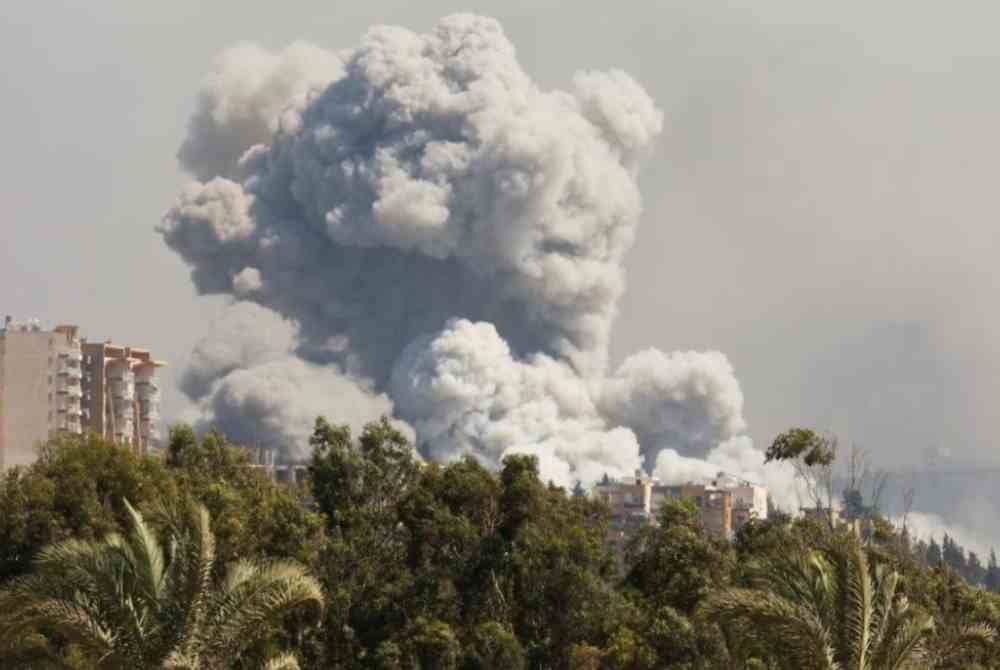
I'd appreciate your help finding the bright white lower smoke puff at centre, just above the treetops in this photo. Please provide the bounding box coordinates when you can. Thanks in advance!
[390,320,642,483]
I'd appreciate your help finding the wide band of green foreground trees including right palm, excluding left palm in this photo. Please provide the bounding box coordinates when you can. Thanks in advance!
[0,419,1000,670]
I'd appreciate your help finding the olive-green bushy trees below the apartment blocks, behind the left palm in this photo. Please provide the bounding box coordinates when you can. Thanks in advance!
[0,425,324,585]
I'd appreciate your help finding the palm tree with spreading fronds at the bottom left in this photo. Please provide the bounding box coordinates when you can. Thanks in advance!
[0,501,323,670]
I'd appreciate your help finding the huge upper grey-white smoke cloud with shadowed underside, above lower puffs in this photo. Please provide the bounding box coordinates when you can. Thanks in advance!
[160,15,662,383]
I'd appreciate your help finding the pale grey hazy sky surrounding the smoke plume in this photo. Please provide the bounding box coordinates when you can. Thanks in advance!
[0,0,1000,476]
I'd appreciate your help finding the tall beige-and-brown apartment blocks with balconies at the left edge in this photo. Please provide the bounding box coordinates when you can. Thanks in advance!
[0,317,163,469]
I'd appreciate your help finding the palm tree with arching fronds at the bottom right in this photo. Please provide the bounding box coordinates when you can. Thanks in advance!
[701,532,993,670]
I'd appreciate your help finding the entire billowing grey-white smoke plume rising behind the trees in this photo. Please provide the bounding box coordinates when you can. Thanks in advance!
[159,15,780,496]
